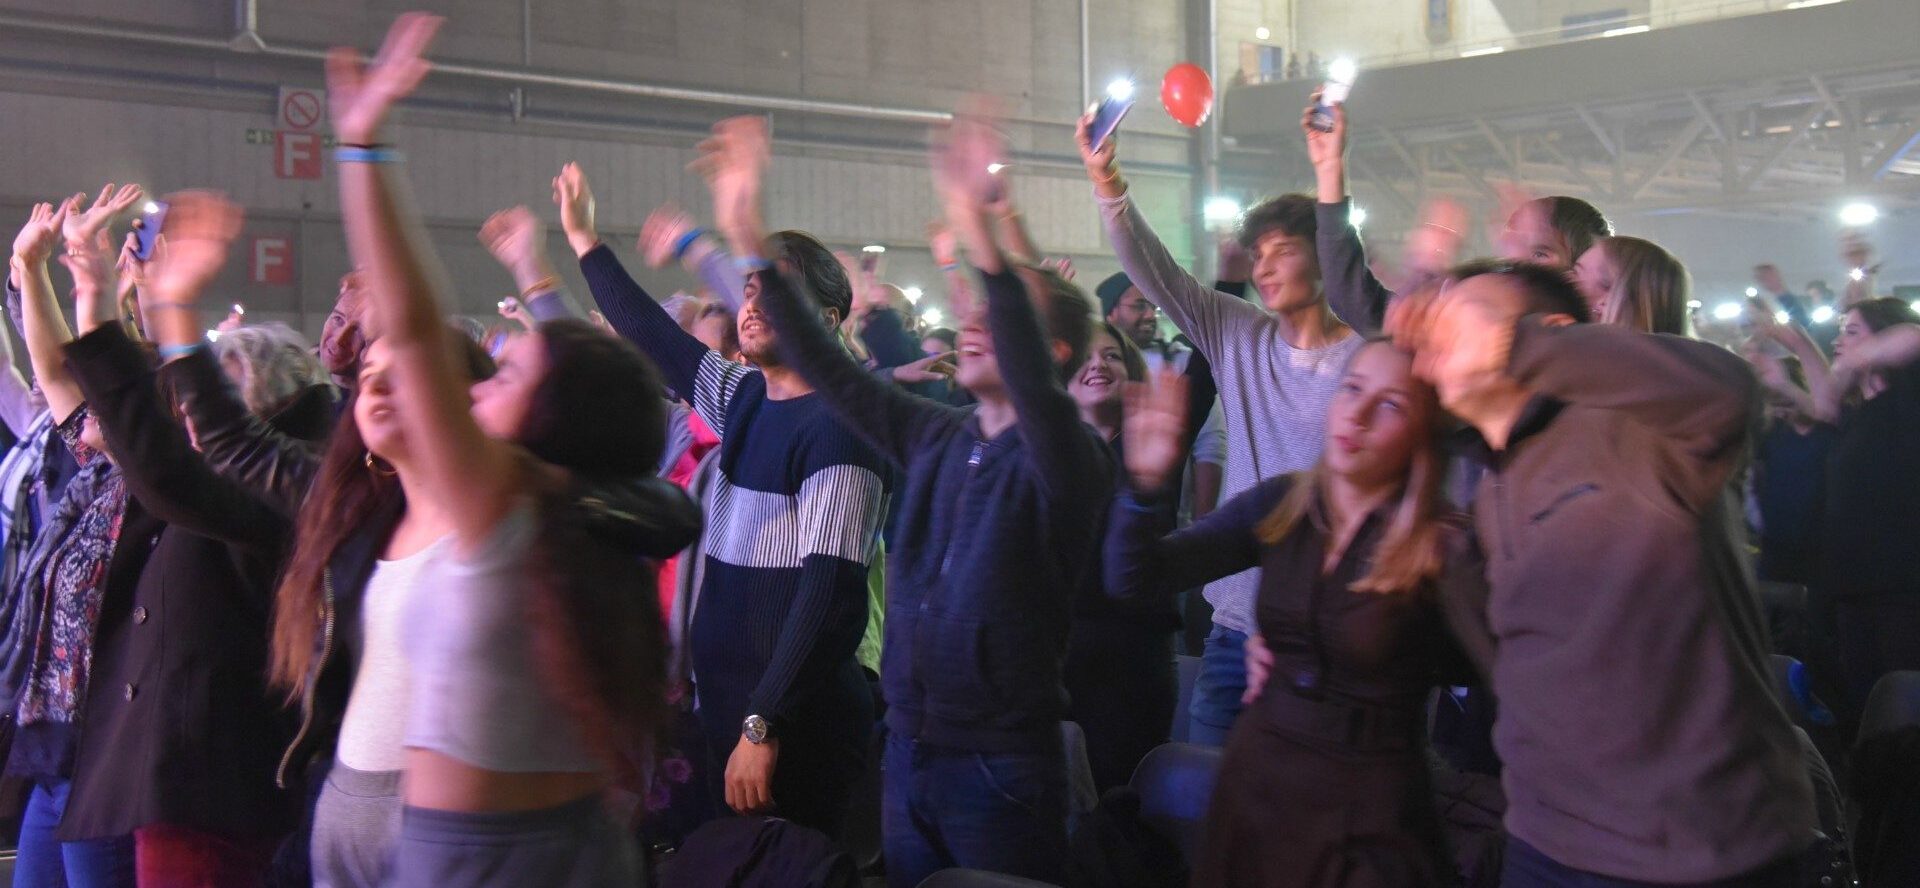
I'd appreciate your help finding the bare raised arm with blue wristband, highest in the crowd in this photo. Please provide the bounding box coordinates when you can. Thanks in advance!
[326,13,526,554]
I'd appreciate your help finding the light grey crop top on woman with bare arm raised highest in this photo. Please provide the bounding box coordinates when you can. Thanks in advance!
[403,504,605,773]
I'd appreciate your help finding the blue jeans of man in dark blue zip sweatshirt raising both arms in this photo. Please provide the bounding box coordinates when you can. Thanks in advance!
[881,735,1068,888]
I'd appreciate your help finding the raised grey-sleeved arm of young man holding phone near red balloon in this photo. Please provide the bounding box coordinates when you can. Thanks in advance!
[1079,115,1265,355]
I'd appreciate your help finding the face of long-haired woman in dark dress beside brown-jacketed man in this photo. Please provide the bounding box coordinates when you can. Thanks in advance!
[1325,341,1434,487]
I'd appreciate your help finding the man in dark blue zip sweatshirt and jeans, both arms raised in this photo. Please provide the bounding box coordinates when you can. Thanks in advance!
[721,105,1114,888]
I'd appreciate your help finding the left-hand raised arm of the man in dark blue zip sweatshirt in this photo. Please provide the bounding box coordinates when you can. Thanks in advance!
[695,117,962,466]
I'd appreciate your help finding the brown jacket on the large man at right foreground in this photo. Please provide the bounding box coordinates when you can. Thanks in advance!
[1475,318,1814,882]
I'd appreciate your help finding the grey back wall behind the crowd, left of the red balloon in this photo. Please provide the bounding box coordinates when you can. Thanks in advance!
[0,0,1194,341]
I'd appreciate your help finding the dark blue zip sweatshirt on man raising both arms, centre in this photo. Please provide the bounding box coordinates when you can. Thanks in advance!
[758,262,1116,752]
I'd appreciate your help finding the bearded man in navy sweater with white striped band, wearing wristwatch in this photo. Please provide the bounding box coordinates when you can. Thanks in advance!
[553,165,887,836]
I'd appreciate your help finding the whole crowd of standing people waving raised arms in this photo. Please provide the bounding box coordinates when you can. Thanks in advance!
[0,13,1920,888]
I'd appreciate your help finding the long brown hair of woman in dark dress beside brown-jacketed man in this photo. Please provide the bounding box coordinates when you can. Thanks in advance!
[1254,339,1446,593]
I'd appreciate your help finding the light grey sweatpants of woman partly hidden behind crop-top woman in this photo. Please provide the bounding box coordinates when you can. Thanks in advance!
[311,759,403,888]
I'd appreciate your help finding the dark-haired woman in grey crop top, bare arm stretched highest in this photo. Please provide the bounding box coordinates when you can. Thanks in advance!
[326,13,698,888]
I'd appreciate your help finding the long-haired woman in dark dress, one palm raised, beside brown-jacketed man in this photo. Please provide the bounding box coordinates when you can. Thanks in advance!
[1106,343,1478,888]
